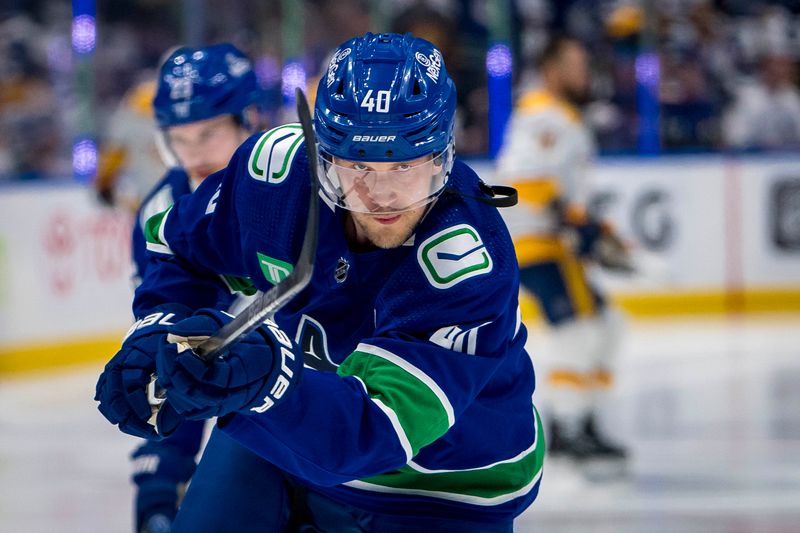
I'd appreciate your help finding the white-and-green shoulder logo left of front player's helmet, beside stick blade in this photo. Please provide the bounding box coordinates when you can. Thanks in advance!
[247,124,303,185]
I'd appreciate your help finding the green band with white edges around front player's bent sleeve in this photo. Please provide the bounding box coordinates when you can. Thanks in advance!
[337,345,451,456]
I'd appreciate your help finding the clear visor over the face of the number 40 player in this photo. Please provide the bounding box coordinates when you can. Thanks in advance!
[319,149,452,213]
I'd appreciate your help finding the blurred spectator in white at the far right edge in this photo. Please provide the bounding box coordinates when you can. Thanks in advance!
[722,50,800,149]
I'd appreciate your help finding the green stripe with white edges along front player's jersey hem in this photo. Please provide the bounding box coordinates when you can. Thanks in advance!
[345,409,545,505]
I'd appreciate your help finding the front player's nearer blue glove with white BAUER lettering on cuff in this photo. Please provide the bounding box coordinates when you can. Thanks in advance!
[157,309,303,420]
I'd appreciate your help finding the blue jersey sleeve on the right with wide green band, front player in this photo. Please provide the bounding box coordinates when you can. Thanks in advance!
[220,198,524,485]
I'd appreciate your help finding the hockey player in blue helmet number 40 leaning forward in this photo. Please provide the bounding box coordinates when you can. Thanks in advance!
[95,33,544,533]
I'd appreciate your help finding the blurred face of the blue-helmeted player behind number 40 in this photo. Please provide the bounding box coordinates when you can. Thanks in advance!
[166,115,247,183]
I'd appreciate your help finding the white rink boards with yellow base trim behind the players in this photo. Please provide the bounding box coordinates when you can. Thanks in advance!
[0,155,800,374]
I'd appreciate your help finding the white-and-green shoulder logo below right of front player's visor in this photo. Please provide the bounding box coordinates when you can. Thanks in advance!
[417,224,492,289]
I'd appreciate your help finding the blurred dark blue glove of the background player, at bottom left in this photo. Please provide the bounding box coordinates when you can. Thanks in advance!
[132,441,196,533]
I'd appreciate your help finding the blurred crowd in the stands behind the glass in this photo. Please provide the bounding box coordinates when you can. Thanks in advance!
[0,0,800,181]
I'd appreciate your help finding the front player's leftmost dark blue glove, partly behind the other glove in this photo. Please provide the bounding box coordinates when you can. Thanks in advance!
[94,304,191,440]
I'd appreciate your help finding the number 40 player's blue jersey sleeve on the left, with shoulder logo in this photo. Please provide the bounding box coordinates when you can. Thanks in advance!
[134,125,310,316]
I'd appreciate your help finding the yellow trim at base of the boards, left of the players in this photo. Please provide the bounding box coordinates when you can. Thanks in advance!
[0,333,124,375]
